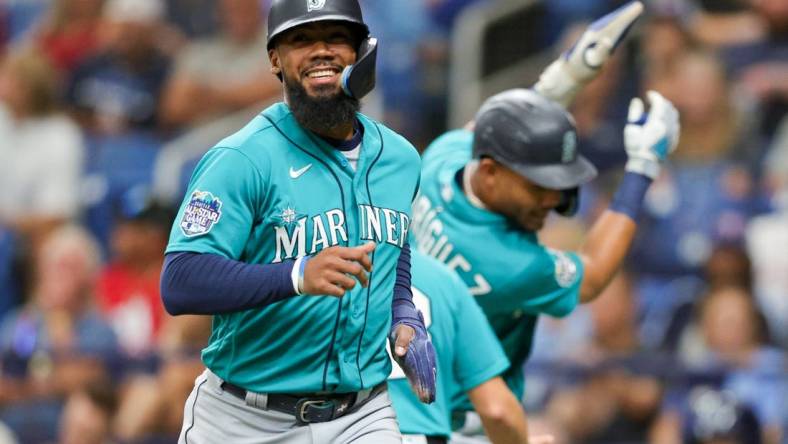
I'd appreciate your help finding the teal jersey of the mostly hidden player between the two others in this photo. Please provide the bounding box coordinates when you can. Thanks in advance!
[389,251,509,437]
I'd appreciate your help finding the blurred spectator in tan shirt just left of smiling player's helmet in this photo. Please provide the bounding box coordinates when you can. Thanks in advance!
[162,0,281,127]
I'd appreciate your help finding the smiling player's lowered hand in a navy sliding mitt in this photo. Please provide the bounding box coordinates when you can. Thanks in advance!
[389,312,437,404]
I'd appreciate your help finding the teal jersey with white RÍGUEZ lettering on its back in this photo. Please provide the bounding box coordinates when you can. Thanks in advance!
[411,130,583,409]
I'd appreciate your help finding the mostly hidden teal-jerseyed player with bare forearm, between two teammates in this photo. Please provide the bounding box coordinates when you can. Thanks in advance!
[389,252,540,444]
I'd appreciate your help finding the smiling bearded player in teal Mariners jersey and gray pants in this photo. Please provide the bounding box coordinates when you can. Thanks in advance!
[162,0,435,444]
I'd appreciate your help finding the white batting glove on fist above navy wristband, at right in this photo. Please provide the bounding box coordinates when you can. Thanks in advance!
[624,91,681,179]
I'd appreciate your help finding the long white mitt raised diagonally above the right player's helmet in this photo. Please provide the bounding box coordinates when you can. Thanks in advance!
[534,1,643,107]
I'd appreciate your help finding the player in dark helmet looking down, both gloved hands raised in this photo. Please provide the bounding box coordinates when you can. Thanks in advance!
[411,2,679,438]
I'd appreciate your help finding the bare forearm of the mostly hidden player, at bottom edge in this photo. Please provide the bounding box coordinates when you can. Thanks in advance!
[468,378,528,444]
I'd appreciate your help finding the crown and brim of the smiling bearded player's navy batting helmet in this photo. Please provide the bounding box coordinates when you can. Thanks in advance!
[268,0,369,49]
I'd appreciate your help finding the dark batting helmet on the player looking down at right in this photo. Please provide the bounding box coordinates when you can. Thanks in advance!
[473,88,597,215]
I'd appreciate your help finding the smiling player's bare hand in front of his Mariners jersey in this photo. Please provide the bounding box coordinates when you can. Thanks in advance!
[301,242,375,298]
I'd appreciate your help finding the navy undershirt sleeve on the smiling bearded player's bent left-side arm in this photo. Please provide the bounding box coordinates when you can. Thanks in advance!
[161,252,296,315]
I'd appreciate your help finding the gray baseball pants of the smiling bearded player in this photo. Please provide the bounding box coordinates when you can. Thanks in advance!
[178,370,402,444]
